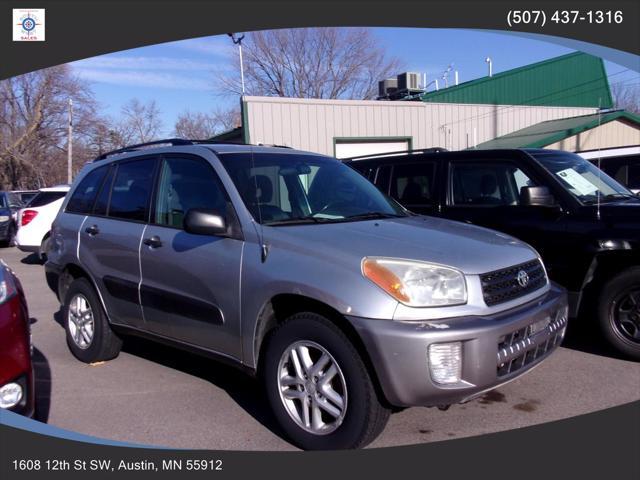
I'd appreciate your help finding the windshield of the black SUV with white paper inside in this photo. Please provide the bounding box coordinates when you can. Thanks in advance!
[534,152,637,203]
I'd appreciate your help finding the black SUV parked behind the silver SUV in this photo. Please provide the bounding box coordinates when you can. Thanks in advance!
[345,149,640,359]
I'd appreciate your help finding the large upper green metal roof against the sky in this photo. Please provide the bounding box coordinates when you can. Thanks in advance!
[420,52,613,108]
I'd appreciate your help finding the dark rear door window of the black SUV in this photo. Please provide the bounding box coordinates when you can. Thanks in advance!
[391,162,435,206]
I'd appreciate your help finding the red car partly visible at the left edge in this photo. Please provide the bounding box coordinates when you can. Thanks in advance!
[0,260,35,417]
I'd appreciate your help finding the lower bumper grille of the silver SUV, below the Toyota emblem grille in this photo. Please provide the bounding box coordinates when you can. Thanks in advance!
[497,308,568,377]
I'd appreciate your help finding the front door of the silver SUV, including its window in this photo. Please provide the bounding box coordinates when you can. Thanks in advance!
[140,154,243,358]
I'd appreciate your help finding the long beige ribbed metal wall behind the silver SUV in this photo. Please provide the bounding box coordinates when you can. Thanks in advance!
[244,97,596,155]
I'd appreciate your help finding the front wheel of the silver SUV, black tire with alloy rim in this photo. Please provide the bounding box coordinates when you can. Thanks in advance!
[262,313,390,450]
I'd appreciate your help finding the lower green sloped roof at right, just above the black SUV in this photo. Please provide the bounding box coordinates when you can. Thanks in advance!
[477,110,640,150]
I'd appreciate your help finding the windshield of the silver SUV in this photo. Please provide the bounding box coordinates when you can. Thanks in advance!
[220,153,408,225]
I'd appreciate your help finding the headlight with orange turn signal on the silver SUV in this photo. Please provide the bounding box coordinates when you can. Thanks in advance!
[362,257,467,307]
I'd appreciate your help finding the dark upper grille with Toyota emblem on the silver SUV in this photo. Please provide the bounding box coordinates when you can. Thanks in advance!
[480,260,547,306]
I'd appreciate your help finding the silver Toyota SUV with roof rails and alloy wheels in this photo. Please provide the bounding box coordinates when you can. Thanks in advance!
[46,140,567,449]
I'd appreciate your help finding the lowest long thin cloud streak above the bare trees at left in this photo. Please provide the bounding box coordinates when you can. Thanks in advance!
[76,68,213,91]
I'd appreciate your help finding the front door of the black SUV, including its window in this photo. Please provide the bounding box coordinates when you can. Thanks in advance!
[442,158,566,262]
